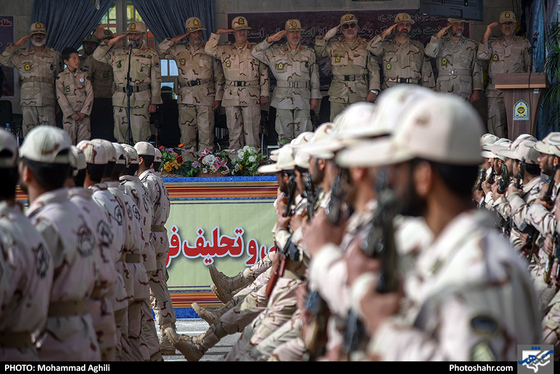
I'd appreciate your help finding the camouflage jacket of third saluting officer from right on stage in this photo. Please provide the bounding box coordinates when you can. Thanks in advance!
[368,35,435,89]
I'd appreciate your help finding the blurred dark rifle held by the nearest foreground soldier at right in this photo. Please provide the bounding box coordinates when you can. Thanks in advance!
[343,170,398,358]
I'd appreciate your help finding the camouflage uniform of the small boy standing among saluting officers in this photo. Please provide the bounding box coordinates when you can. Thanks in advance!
[56,68,93,145]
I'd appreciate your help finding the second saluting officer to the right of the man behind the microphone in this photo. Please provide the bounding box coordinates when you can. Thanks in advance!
[204,17,270,149]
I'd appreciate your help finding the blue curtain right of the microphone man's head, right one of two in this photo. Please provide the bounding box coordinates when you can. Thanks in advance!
[132,0,215,42]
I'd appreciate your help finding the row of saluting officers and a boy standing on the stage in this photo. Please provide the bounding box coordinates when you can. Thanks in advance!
[0,11,531,158]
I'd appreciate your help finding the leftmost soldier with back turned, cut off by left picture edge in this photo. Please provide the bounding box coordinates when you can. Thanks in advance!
[0,130,53,361]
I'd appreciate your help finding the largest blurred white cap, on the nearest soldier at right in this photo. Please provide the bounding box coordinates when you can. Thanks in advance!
[337,92,484,167]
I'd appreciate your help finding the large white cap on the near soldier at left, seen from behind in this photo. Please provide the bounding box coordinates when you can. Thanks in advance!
[19,125,72,164]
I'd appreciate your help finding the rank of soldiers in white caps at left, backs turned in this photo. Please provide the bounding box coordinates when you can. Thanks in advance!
[0,125,175,361]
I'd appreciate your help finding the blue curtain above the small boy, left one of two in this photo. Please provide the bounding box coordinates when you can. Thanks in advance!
[31,0,115,51]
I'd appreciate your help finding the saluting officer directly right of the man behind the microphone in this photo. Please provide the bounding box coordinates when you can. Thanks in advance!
[158,17,225,160]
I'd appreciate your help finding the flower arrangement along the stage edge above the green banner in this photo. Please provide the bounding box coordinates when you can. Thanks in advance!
[159,144,263,177]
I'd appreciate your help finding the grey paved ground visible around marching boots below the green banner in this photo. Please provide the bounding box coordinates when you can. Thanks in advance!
[163,319,241,361]
